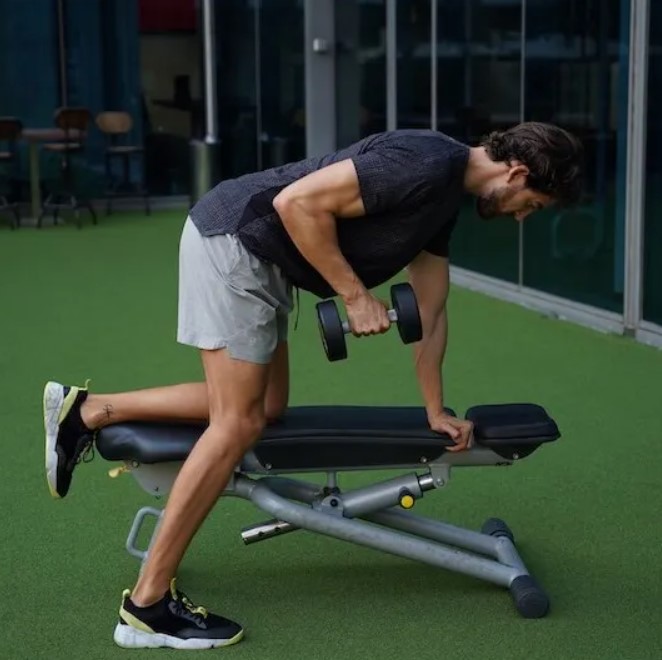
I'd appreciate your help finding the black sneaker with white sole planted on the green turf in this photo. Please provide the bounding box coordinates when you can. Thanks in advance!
[113,579,244,649]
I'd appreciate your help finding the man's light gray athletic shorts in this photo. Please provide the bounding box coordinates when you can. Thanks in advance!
[177,218,292,364]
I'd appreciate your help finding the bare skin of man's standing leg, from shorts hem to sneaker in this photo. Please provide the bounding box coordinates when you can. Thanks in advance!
[131,350,269,607]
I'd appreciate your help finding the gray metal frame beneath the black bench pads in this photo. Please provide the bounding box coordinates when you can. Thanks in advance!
[118,446,549,618]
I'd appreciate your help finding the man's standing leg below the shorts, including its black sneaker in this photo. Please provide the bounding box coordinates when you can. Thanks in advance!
[113,350,270,649]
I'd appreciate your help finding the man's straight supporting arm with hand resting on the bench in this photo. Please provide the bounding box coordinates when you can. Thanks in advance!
[407,252,472,451]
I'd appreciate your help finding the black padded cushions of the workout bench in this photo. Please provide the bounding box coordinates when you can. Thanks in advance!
[96,404,559,470]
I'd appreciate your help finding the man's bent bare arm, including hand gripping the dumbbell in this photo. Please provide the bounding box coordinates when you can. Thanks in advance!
[273,160,390,334]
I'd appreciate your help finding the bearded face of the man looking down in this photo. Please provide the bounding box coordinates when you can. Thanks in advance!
[476,166,554,222]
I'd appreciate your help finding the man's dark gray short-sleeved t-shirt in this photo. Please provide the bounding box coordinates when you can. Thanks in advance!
[191,130,469,298]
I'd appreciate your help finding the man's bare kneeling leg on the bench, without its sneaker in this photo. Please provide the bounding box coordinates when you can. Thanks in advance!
[81,342,289,429]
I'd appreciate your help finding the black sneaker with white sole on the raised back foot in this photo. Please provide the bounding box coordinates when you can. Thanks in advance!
[44,382,94,497]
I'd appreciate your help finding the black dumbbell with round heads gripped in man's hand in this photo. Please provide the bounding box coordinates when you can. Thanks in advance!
[317,282,423,362]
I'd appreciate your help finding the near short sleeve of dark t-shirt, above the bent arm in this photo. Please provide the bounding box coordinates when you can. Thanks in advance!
[352,138,448,215]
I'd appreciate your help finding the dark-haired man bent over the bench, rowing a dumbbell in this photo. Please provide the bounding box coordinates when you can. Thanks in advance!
[44,123,582,648]
